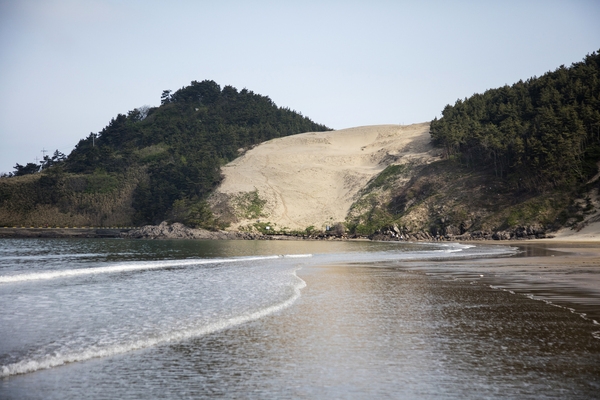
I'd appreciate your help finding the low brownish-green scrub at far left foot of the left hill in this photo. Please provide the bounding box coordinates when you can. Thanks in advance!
[0,167,147,226]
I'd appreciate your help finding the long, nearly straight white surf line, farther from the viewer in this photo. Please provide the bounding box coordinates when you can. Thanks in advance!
[0,254,312,284]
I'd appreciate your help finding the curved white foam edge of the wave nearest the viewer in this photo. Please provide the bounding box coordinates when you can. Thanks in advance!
[0,268,310,378]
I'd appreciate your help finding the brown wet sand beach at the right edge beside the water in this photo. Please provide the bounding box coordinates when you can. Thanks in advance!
[410,240,600,324]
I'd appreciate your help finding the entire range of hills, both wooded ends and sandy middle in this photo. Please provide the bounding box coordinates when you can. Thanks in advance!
[0,53,600,240]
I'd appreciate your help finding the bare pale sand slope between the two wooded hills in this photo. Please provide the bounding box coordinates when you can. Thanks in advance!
[217,123,436,229]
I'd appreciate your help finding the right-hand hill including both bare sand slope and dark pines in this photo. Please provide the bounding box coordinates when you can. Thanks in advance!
[211,53,600,239]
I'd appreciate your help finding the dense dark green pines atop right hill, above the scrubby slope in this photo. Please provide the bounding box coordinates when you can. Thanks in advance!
[431,53,600,190]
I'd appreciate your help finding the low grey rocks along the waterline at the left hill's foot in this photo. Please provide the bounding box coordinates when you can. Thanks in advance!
[121,222,263,240]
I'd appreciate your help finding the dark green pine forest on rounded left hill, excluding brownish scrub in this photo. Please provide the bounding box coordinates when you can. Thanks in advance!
[67,81,327,223]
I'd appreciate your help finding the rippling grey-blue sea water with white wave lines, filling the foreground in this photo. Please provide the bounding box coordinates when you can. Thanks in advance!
[0,239,600,399]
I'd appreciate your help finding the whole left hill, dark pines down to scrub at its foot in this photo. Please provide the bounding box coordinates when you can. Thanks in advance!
[0,80,328,225]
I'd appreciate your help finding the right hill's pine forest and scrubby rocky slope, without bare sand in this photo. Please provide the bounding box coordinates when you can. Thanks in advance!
[347,52,600,240]
